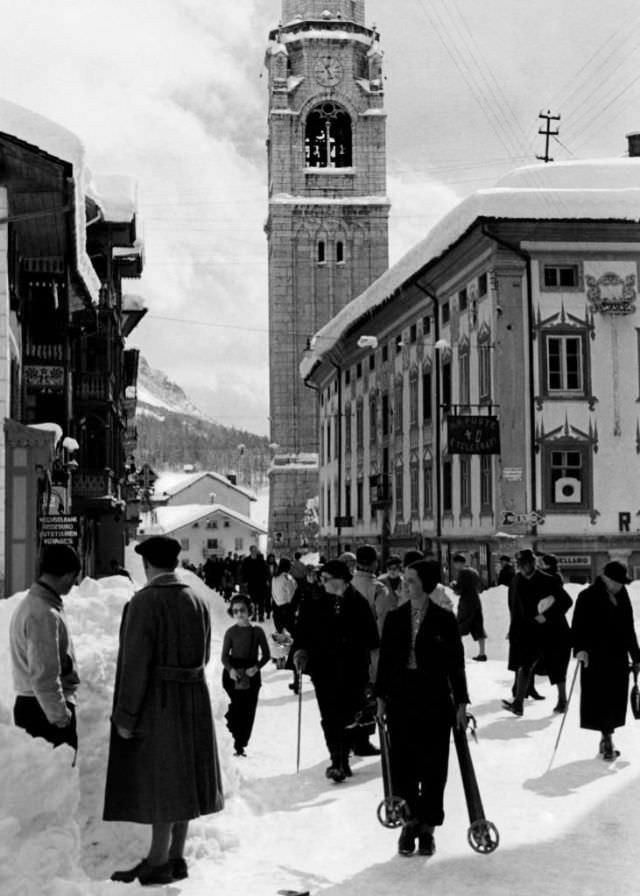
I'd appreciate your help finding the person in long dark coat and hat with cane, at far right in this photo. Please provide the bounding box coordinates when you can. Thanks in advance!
[571,560,640,760]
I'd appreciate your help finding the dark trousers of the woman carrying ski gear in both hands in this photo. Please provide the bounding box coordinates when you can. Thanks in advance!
[387,670,453,827]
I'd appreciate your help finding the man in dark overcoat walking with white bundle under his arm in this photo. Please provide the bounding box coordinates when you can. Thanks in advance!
[502,548,573,716]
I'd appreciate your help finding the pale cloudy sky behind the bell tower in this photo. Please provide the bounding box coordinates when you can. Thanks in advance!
[0,0,640,433]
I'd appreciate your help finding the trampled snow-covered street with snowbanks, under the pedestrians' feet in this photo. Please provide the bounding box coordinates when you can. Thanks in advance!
[0,579,640,896]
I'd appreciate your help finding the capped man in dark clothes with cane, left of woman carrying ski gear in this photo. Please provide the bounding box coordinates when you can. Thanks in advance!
[293,560,379,784]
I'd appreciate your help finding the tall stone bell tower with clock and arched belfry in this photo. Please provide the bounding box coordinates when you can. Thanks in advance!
[266,0,389,552]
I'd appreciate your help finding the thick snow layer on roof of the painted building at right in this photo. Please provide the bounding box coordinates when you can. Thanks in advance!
[300,158,640,379]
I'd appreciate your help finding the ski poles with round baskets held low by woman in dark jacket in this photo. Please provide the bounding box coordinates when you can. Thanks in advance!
[377,714,500,855]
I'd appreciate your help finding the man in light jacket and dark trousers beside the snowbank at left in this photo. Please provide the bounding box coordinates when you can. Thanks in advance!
[9,544,80,750]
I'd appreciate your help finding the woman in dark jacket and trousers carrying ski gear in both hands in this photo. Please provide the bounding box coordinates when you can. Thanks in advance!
[376,560,469,856]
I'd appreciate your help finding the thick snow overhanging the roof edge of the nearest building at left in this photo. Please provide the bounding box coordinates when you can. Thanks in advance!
[0,99,100,303]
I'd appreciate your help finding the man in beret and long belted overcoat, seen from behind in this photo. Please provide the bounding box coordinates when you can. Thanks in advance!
[104,535,223,884]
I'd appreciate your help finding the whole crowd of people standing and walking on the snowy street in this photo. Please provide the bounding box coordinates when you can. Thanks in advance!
[10,536,640,884]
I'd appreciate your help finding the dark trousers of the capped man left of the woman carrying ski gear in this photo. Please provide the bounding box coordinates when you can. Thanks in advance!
[313,674,364,765]
